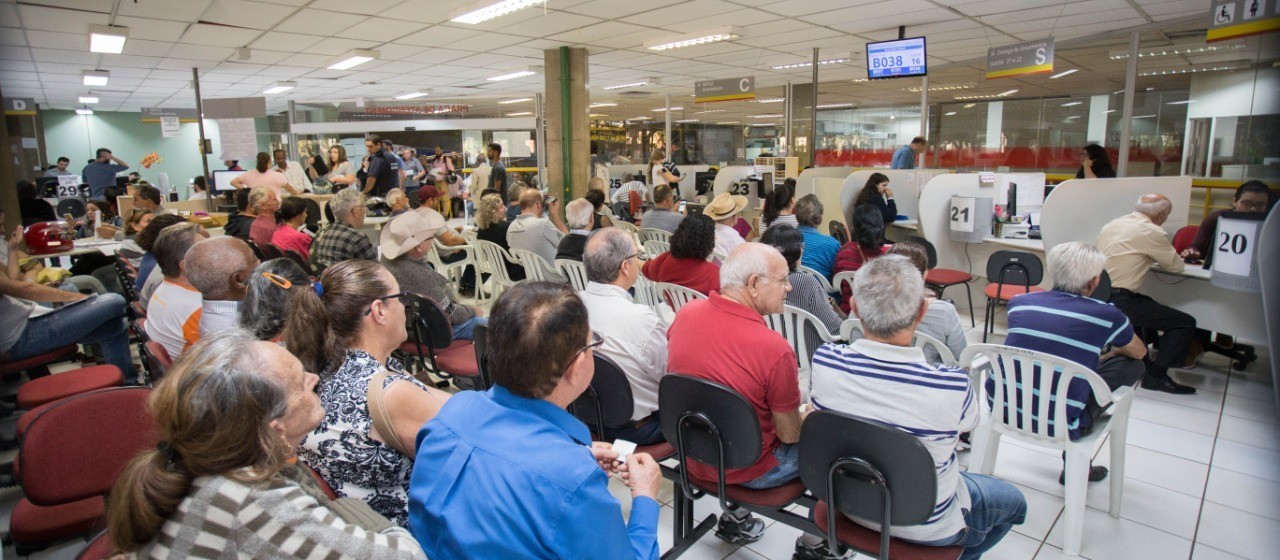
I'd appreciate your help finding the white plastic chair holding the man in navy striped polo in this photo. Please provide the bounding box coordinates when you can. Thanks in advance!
[960,344,1133,556]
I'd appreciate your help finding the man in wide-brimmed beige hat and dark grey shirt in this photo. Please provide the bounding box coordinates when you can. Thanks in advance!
[379,212,489,340]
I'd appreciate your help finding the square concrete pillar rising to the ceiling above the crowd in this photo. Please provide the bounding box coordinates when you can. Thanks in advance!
[543,47,591,203]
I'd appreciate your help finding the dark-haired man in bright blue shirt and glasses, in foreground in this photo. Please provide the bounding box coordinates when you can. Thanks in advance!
[408,283,662,560]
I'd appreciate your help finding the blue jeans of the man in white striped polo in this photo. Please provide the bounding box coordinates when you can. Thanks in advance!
[922,472,1027,560]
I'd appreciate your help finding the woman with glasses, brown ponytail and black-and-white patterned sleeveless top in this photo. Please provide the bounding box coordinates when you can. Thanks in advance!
[284,260,449,525]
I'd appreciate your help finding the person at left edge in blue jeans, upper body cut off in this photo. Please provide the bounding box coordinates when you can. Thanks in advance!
[0,223,138,384]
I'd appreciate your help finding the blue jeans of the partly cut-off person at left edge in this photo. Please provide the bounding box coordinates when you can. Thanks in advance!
[9,294,138,384]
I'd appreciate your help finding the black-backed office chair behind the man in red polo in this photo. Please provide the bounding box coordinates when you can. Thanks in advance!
[658,373,818,557]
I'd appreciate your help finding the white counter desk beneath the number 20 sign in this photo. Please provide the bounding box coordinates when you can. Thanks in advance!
[1142,265,1267,346]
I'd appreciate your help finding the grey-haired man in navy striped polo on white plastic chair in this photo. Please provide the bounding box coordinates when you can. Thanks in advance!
[1003,242,1147,481]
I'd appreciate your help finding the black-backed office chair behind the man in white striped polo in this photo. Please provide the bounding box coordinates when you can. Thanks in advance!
[800,410,964,560]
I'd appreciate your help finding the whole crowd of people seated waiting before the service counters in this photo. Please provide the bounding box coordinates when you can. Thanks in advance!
[0,142,1270,559]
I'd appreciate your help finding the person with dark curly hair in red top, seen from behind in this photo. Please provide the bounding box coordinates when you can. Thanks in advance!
[640,214,719,295]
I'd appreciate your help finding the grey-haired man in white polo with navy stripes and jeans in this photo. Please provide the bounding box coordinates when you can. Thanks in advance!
[810,254,1027,560]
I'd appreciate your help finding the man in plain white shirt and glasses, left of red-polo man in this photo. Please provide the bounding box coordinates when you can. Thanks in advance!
[577,228,667,445]
